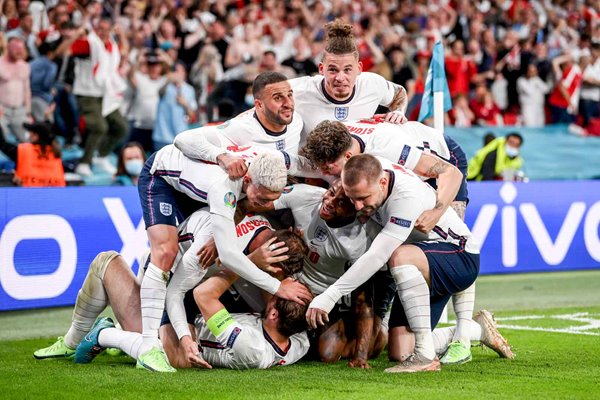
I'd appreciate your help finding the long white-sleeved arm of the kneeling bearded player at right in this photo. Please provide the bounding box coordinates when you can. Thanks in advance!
[306,232,404,328]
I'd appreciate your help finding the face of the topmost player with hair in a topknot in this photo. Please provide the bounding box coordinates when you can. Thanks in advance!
[319,53,362,100]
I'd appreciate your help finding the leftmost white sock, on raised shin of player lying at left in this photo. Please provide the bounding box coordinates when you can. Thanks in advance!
[65,260,108,349]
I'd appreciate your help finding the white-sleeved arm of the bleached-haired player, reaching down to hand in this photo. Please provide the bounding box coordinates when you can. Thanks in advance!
[211,213,312,304]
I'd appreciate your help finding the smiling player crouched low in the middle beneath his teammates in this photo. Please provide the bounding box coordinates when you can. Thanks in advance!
[238,179,395,368]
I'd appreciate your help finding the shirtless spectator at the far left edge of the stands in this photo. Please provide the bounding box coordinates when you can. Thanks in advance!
[0,36,31,142]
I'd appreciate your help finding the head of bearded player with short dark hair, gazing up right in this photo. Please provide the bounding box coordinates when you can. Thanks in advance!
[255,81,294,125]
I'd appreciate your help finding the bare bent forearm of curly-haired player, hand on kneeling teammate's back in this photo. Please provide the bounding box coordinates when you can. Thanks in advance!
[413,153,463,232]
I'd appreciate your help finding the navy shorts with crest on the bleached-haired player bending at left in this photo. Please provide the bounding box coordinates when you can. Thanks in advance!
[138,153,207,229]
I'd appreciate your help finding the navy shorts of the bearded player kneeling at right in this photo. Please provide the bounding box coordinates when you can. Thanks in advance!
[389,242,479,329]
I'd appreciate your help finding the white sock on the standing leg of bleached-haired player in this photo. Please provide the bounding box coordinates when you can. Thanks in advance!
[140,263,167,351]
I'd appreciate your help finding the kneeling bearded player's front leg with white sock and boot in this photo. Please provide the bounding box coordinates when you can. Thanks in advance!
[388,245,439,372]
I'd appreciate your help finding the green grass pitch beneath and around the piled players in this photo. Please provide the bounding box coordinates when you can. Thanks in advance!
[0,271,600,399]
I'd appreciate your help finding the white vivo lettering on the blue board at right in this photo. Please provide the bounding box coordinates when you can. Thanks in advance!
[471,183,600,268]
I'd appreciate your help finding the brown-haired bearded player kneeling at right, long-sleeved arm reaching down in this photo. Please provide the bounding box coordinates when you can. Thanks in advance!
[307,154,479,372]
